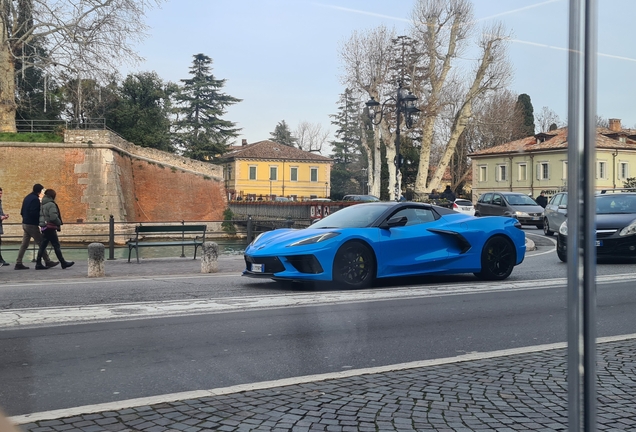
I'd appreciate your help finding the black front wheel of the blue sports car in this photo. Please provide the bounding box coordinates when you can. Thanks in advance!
[332,241,376,289]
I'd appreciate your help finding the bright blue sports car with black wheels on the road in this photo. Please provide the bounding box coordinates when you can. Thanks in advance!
[243,202,526,288]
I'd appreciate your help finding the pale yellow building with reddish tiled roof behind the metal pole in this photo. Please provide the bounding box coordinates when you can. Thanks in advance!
[470,119,636,201]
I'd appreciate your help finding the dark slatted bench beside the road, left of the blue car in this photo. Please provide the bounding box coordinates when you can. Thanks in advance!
[126,225,208,263]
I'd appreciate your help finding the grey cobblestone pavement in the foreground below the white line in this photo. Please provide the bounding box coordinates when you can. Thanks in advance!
[13,339,636,432]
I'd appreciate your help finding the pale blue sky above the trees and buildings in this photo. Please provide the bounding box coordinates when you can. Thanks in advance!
[122,0,636,149]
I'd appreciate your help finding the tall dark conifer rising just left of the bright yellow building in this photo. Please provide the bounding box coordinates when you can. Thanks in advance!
[174,54,241,161]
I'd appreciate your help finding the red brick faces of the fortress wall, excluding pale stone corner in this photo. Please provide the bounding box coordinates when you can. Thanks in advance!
[0,143,226,223]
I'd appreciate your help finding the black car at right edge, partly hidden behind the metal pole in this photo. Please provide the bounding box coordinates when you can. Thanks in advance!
[557,192,636,262]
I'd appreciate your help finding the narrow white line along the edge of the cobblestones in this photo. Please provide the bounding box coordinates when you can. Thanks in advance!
[9,334,636,425]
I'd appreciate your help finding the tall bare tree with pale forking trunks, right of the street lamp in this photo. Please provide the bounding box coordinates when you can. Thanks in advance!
[412,0,511,195]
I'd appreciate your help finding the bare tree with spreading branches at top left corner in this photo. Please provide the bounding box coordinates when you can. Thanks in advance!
[0,0,161,132]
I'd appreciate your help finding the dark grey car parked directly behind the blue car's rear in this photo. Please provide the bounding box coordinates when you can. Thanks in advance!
[475,192,543,229]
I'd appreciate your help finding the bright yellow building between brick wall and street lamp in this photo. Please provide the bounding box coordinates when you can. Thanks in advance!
[223,140,332,201]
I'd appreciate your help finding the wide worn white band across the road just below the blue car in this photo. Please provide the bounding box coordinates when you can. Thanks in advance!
[0,274,636,331]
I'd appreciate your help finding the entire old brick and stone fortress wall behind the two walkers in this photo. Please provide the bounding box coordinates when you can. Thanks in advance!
[0,130,227,240]
